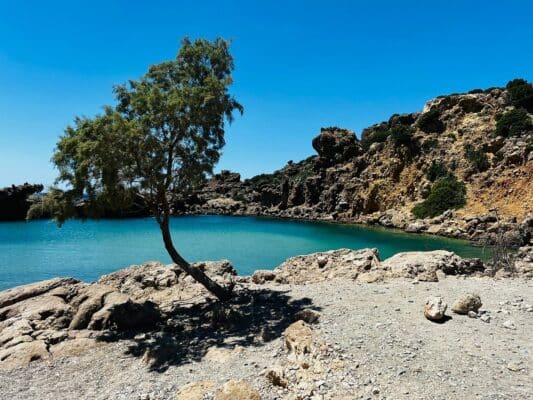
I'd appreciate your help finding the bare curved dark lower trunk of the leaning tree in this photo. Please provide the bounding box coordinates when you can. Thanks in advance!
[159,217,232,301]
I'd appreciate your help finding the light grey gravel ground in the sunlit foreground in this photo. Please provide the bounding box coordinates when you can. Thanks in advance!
[0,277,533,400]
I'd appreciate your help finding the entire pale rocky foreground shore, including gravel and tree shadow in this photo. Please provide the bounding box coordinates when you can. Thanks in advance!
[0,249,533,400]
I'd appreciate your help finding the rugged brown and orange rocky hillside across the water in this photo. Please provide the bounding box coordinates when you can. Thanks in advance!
[178,80,533,245]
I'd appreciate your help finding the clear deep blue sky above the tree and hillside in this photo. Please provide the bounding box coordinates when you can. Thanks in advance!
[0,0,533,186]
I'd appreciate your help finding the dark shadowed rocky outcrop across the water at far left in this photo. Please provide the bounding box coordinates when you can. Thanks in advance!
[0,183,43,221]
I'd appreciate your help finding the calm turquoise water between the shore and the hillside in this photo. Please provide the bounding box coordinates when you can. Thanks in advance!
[0,216,482,290]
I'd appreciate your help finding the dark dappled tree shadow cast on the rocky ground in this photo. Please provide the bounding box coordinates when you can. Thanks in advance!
[100,288,320,372]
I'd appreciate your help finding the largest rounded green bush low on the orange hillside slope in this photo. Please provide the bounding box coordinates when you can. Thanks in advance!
[412,174,466,218]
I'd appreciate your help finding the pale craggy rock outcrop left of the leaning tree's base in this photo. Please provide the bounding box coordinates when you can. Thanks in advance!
[0,261,236,368]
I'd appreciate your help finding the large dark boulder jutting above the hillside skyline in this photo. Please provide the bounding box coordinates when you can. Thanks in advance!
[312,127,362,165]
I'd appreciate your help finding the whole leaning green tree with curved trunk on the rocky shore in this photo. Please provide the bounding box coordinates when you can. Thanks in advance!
[29,38,243,300]
